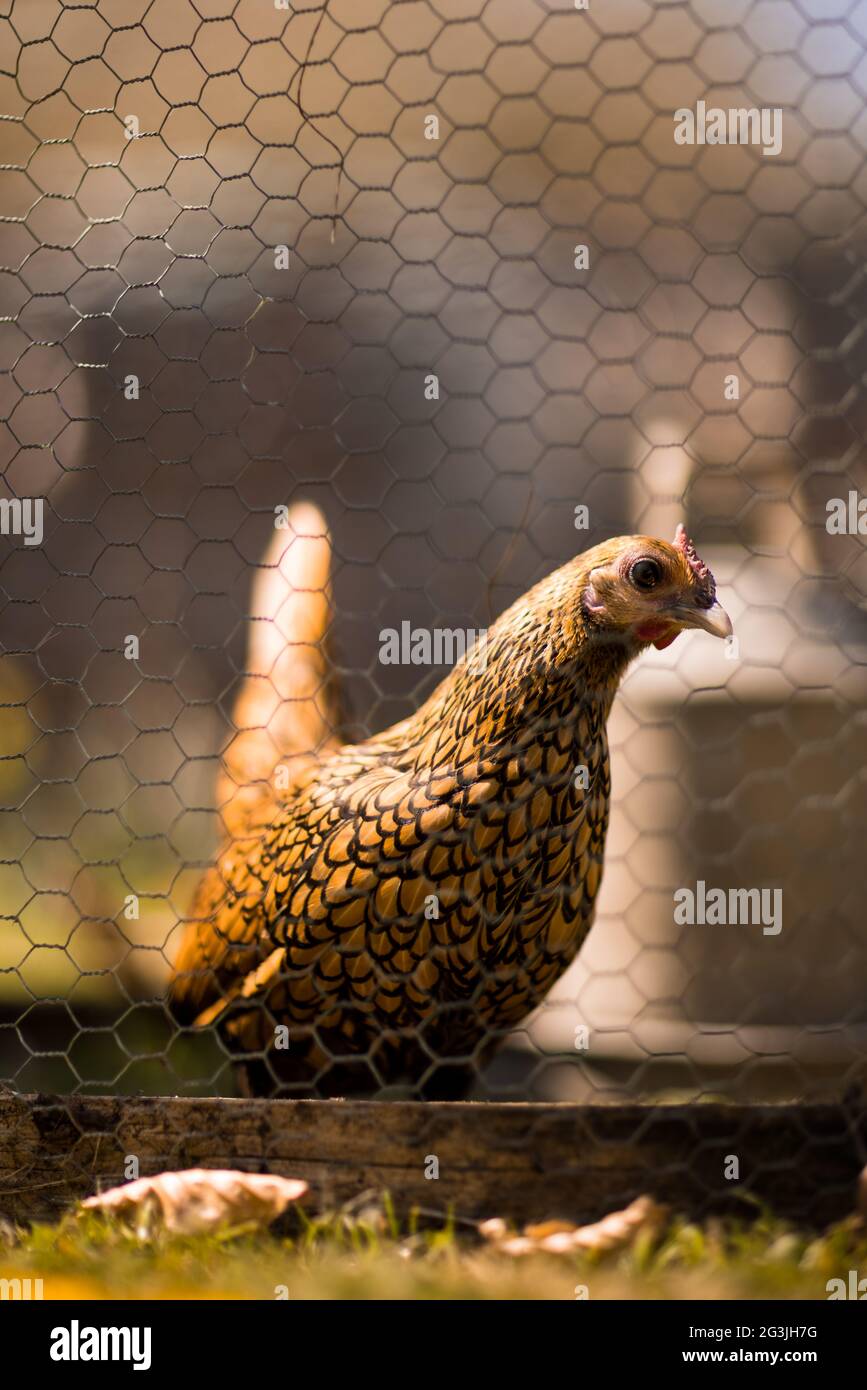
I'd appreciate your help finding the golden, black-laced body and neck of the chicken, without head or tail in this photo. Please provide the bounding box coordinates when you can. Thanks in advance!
[174,511,733,1091]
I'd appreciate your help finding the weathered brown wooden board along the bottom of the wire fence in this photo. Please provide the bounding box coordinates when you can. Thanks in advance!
[0,1094,867,1225]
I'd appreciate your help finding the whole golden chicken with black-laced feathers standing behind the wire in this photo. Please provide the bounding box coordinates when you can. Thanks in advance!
[170,505,731,1095]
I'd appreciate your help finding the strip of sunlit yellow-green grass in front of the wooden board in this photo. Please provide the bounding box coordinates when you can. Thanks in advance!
[0,1198,867,1300]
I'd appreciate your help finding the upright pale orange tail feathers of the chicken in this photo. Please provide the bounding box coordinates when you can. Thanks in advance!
[217,502,339,834]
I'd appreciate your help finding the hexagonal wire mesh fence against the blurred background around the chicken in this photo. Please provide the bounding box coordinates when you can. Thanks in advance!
[0,0,867,1117]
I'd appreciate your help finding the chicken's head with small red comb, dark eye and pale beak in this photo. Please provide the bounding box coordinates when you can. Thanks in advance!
[582,525,732,649]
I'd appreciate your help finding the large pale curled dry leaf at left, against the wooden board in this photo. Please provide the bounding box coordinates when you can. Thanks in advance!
[82,1168,307,1236]
